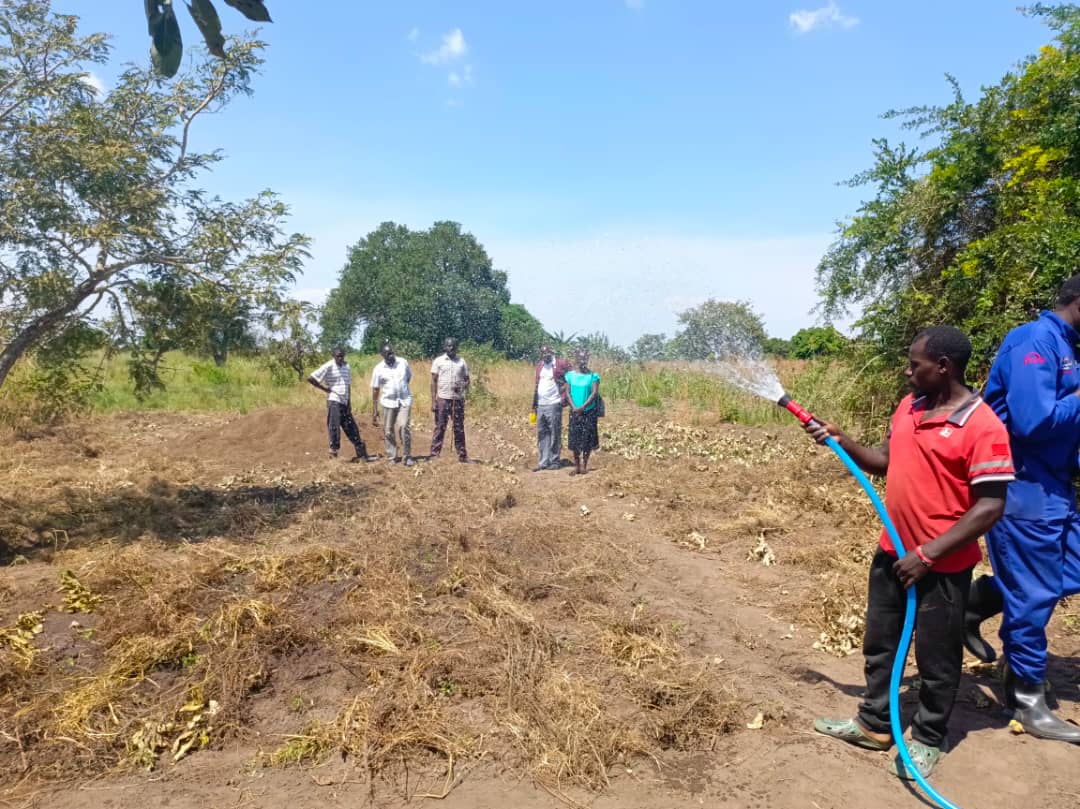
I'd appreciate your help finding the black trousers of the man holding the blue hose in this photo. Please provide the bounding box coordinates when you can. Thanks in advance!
[859,549,971,747]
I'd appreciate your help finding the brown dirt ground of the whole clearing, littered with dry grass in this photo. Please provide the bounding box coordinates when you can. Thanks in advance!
[0,407,1080,809]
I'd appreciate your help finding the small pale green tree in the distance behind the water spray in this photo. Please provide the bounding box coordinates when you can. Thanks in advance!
[672,298,768,360]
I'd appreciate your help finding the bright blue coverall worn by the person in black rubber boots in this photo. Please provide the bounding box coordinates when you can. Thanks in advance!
[983,312,1080,683]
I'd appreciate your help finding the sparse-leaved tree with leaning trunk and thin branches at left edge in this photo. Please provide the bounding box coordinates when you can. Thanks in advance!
[0,0,308,386]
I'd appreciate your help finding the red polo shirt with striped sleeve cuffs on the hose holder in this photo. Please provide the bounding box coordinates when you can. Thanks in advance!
[881,395,1013,574]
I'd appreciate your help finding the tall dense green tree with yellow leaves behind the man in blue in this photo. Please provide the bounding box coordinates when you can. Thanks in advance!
[818,4,1080,375]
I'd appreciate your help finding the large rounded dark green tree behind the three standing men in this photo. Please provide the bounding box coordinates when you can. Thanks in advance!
[322,221,542,356]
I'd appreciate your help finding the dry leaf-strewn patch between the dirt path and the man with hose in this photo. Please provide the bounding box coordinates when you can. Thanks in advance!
[591,412,880,657]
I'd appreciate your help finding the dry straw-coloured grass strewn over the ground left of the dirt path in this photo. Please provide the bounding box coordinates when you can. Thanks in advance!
[0,403,740,794]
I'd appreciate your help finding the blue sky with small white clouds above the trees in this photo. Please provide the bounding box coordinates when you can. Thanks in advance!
[71,0,1050,343]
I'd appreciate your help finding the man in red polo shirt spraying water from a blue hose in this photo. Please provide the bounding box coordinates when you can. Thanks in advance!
[807,326,1013,778]
